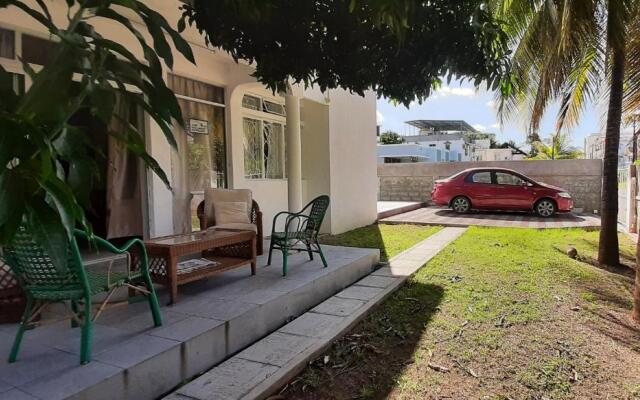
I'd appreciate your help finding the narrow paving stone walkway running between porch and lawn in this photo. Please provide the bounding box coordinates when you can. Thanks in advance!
[165,227,466,400]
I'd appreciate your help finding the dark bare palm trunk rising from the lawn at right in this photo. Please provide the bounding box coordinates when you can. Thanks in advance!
[598,46,625,266]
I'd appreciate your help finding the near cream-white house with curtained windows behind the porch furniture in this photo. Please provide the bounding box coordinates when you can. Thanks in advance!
[0,0,378,238]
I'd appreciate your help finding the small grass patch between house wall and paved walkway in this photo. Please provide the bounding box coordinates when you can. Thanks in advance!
[320,225,442,261]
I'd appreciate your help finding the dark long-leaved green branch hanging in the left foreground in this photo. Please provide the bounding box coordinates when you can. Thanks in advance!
[0,0,195,265]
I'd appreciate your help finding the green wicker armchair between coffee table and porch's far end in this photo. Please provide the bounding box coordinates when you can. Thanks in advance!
[267,195,329,276]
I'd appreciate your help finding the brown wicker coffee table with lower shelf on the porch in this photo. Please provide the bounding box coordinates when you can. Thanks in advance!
[145,229,256,304]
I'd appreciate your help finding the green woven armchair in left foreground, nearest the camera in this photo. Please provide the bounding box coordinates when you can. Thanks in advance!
[2,226,162,364]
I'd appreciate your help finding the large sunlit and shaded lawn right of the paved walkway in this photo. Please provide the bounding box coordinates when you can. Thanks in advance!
[280,227,640,400]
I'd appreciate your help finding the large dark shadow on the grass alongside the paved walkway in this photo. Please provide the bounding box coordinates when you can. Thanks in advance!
[281,280,444,399]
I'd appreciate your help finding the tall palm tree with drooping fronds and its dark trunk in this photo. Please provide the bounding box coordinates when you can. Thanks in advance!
[493,0,640,265]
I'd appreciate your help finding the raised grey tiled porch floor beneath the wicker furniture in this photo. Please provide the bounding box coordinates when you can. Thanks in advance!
[0,242,379,400]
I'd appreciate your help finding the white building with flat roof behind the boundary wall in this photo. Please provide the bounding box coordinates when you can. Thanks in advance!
[378,120,495,164]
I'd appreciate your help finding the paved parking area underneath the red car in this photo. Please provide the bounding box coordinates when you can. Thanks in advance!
[379,207,600,228]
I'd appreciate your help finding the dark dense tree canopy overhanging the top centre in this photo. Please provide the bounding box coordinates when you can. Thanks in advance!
[181,0,509,105]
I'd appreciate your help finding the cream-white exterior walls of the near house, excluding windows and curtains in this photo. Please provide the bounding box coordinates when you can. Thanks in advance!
[0,0,377,237]
